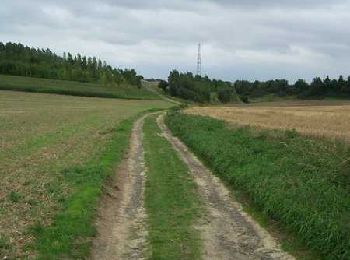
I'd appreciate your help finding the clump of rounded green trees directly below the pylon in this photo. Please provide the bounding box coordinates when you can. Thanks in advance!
[168,70,237,103]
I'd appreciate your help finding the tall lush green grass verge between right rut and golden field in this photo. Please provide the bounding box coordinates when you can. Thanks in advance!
[166,113,350,259]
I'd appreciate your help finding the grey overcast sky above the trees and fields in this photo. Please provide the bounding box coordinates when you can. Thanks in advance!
[0,0,350,80]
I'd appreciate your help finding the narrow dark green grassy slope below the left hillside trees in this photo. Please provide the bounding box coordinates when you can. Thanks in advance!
[0,75,159,99]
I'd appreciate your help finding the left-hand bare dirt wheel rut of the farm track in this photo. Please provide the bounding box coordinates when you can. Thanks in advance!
[91,116,147,260]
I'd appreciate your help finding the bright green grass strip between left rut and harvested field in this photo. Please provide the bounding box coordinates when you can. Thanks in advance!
[31,117,136,259]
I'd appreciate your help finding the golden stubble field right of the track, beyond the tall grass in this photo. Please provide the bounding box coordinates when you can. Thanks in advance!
[186,101,350,140]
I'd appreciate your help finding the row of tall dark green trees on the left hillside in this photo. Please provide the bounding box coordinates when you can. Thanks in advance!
[0,42,142,87]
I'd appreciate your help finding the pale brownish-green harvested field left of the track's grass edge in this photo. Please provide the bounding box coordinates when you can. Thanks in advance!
[0,91,169,259]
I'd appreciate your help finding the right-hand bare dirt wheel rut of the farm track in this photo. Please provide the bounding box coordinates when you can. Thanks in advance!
[157,114,294,260]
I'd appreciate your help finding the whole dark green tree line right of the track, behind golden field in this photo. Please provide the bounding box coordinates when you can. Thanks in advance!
[159,70,350,103]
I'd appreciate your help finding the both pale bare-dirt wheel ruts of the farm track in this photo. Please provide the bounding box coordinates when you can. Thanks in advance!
[92,115,294,260]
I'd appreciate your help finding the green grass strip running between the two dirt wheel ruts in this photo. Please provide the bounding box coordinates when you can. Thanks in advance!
[144,117,200,260]
